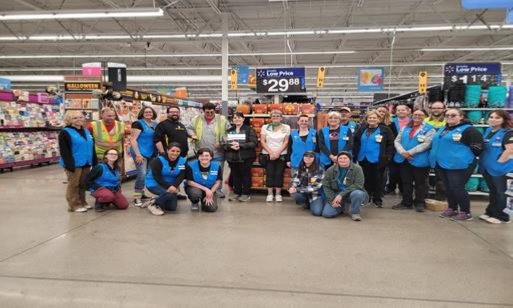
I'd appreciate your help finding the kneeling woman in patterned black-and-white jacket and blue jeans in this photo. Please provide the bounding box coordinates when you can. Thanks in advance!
[289,151,325,216]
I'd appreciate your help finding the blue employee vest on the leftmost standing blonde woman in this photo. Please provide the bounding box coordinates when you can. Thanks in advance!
[59,127,94,168]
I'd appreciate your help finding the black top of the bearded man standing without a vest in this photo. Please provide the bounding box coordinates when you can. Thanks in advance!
[153,119,189,157]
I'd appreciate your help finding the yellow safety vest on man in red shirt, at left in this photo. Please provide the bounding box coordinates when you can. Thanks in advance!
[92,120,125,159]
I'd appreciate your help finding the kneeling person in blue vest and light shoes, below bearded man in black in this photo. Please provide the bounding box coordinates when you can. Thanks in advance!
[143,142,187,216]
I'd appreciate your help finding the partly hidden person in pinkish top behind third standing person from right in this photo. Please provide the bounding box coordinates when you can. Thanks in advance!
[385,104,411,194]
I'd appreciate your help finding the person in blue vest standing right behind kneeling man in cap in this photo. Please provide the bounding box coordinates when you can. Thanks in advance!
[317,111,353,169]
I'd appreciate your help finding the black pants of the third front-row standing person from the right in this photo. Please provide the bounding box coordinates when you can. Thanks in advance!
[400,161,431,207]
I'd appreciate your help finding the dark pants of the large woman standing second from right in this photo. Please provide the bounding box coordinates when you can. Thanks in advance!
[436,162,476,214]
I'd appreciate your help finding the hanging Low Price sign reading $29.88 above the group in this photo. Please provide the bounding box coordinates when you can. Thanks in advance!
[256,67,306,94]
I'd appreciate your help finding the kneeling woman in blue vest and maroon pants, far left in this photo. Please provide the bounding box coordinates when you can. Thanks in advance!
[87,149,128,212]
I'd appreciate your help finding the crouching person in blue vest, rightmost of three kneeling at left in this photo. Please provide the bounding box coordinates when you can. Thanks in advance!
[185,148,223,212]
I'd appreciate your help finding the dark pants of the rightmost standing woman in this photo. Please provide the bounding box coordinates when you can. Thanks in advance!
[483,171,509,221]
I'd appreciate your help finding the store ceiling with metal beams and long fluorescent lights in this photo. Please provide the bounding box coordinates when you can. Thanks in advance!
[0,0,513,98]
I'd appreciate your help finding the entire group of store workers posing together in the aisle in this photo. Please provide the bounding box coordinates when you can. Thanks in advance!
[59,102,513,224]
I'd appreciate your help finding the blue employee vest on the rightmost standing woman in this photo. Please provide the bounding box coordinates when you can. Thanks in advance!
[479,128,513,176]
